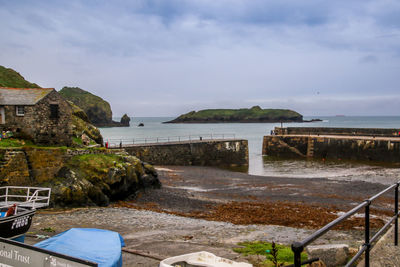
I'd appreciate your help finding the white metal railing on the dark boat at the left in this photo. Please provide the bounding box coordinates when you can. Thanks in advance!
[0,186,51,209]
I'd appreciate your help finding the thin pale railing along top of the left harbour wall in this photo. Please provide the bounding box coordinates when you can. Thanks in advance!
[104,133,235,147]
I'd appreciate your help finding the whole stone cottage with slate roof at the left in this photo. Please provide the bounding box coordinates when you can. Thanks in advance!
[0,87,72,146]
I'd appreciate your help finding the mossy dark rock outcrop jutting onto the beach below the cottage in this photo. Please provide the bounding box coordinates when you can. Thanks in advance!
[51,154,161,206]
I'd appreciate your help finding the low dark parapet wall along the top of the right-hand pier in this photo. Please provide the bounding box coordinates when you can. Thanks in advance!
[274,127,400,137]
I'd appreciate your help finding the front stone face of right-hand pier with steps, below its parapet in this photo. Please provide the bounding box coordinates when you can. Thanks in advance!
[263,135,400,163]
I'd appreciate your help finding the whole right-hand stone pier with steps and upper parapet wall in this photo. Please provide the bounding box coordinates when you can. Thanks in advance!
[263,127,400,163]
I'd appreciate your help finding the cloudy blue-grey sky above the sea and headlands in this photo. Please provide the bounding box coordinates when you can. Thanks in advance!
[0,0,400,117]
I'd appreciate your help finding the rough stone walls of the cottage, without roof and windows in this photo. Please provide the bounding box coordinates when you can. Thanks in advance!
[0,90,72,146]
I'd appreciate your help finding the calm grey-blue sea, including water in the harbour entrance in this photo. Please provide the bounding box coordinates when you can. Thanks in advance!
[100,117,400,184]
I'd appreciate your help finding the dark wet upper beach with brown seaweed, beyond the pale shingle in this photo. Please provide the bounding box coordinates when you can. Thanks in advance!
[131,166,393,229]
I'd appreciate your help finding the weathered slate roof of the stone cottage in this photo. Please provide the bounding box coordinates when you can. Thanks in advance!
[0,87,54,106]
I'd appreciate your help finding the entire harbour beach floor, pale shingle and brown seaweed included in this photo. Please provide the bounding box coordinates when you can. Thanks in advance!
[27,166,392,266]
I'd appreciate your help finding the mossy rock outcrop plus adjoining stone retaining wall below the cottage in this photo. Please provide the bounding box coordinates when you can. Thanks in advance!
[0,147,161,207]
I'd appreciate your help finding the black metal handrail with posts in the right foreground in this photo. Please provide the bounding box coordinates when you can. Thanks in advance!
[292,182,400,267]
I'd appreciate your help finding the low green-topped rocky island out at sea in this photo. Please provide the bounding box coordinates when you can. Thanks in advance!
[164,106,303,123]
